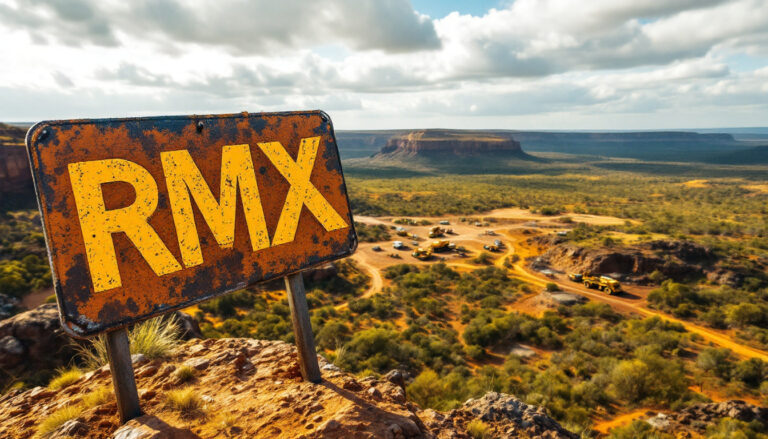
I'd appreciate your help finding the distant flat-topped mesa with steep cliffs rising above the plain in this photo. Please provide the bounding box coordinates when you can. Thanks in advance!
[380,130,523,157]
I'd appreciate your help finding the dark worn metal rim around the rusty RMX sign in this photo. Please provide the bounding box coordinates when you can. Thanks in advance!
[25,110,358,339]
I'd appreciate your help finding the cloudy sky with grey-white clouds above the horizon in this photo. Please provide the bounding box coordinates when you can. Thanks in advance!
[0,0,768,129]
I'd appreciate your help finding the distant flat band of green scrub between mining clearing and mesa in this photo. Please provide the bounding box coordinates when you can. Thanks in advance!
[348,171,768,252]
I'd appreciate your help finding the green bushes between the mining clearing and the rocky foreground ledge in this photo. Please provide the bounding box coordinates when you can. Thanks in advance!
[189,263,762,437]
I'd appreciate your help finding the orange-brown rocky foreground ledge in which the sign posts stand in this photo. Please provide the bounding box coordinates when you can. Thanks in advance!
[0,339,575,439]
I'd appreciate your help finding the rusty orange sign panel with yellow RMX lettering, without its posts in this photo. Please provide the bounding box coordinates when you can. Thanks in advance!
[27,111,357,338]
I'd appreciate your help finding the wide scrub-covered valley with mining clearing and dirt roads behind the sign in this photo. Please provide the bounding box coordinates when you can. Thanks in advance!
[0,122,768,438]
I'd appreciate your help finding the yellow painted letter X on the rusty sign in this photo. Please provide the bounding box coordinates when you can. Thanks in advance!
[259,137,348,245]
